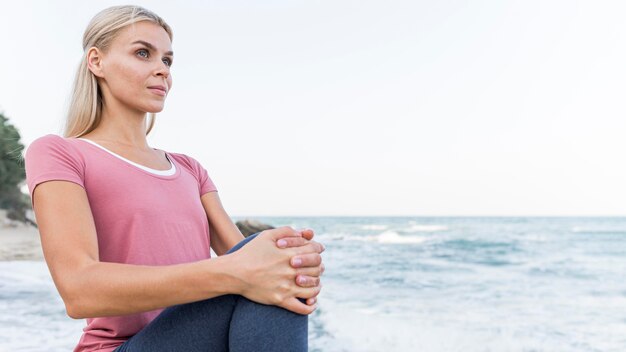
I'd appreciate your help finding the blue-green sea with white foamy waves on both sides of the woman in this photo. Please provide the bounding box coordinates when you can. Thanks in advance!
[0,217,626,352]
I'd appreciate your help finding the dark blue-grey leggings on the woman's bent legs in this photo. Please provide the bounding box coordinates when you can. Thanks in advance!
[113,233,309,352]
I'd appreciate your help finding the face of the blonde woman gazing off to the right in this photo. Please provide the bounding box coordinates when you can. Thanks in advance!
[89,21,174,113]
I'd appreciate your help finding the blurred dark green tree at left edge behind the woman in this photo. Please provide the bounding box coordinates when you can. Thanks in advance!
[0,113,30,222]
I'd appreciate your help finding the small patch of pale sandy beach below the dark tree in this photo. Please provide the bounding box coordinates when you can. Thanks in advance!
[0,224,44,261]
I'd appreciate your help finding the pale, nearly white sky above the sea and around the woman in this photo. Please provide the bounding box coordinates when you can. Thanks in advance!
[0,0,626,216]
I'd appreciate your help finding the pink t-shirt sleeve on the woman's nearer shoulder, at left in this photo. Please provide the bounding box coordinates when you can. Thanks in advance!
[24,134,85,205]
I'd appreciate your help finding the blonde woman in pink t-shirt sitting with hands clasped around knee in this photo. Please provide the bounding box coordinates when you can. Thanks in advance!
[25,6,324,351]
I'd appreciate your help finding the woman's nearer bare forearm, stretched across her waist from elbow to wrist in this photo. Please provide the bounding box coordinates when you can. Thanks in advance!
[64,255,242,319]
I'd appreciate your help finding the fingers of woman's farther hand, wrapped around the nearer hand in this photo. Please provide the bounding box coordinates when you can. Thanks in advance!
[276,229,325,305]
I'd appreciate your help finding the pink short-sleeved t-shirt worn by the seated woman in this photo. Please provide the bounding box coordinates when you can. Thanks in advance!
[24,134,217,352]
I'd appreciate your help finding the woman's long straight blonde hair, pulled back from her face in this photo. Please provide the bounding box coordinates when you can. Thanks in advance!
[63,5,173,137]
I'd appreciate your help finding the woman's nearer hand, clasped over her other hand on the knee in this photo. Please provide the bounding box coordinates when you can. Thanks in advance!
[224,226,322,314]
